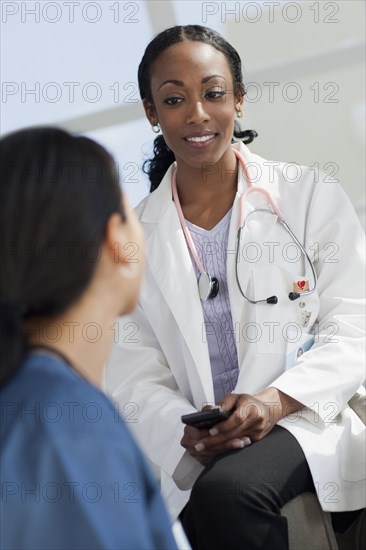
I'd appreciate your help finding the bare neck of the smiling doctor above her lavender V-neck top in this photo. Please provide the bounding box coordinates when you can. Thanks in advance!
[177,147,238,229]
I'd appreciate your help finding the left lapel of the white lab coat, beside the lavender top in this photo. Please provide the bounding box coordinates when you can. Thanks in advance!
[141,167,214,402]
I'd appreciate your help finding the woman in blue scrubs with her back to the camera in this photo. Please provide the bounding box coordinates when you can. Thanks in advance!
[0,128,176,550]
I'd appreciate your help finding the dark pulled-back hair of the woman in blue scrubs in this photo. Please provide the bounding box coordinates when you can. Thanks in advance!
[0,128,125,385]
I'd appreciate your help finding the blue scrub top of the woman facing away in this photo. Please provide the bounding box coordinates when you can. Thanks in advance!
[0,352,176,550]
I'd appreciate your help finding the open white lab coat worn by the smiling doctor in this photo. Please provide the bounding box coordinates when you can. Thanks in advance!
[105,144,365,516]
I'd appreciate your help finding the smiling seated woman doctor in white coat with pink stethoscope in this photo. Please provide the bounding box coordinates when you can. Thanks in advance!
[106,25,365,549]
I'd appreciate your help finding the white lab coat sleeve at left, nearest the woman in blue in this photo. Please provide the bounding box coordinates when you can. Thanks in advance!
[105,306,198,488]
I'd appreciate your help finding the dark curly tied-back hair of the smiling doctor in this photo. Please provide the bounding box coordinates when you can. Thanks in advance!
[138,25,257,192]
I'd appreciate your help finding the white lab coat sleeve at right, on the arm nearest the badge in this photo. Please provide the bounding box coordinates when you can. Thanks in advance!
[271,175,365,425]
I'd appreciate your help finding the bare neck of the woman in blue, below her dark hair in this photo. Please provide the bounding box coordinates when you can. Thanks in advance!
[25,299,116,387]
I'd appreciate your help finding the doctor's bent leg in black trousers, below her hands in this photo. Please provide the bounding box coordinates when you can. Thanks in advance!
[182,426,314,550]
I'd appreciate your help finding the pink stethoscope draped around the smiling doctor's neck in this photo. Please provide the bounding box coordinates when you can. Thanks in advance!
[172,149,317,304]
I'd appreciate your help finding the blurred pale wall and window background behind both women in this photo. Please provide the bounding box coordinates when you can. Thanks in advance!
[0,0,365,226]
